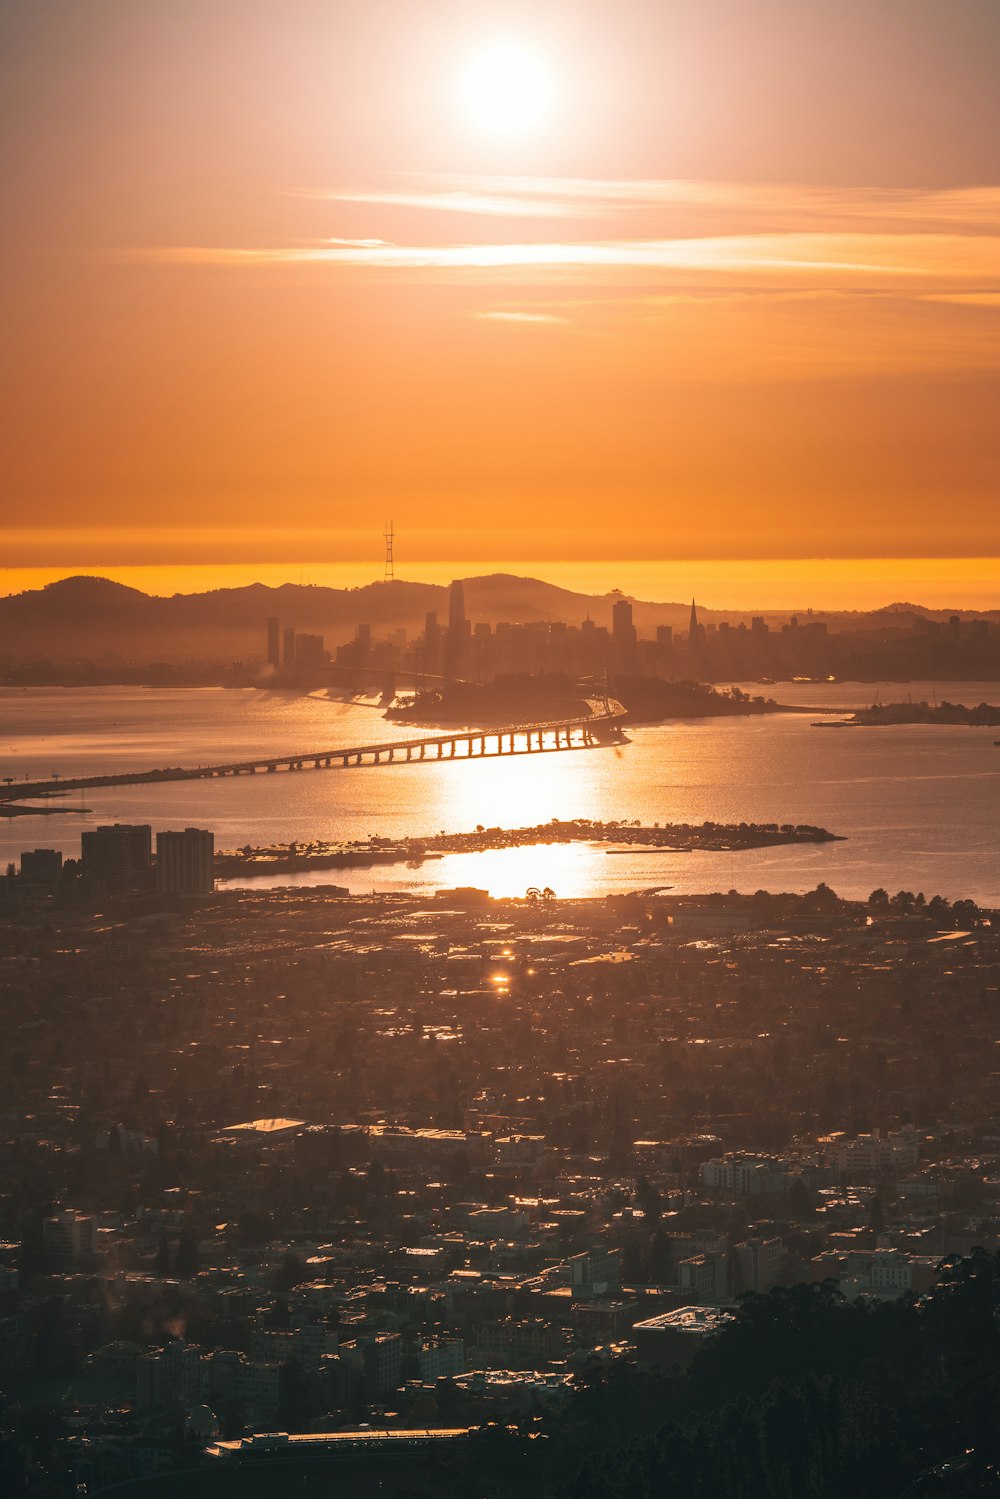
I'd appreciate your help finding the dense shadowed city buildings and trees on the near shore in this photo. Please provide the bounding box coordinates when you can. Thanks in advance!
[0,851,1000,1495]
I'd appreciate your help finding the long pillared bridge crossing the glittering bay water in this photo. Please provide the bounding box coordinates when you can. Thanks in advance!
[0,700,625,802]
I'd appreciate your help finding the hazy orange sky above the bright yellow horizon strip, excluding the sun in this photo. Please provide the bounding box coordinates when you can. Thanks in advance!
[0,0,1000,593]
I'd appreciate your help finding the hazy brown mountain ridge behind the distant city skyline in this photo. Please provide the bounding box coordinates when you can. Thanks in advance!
[0,573,1000,663]
